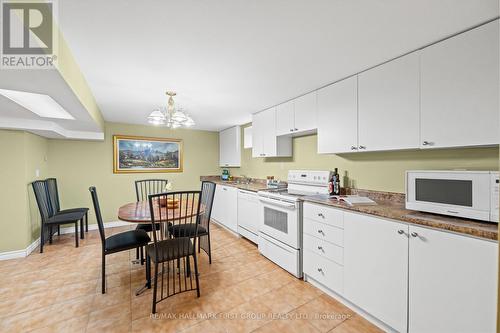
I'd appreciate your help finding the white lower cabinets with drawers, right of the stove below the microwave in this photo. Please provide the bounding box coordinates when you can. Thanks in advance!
[303,202,498,333]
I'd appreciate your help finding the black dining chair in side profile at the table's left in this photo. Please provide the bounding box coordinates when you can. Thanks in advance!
[89,186,151,294]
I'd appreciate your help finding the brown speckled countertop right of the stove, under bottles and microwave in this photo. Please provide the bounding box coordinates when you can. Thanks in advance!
[302,192,498,240]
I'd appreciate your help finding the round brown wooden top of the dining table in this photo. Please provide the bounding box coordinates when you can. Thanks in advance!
[118,200,204,223]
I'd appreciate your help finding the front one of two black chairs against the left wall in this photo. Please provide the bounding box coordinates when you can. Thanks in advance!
[31,180,85,253]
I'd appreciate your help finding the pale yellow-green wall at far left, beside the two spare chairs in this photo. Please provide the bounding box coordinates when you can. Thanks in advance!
[0,130,48,252]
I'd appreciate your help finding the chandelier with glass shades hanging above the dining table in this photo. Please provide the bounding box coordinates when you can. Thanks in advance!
[148,91,194,128]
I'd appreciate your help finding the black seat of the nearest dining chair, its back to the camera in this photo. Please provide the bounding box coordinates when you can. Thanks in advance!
[146,237,194,263]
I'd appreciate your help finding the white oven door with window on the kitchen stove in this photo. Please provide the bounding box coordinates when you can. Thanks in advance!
[259,197,300,249]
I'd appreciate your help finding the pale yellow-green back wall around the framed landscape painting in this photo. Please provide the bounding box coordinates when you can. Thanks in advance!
[49,123,219,228]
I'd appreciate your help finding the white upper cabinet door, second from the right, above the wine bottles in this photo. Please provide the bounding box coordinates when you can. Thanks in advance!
[358,52,420,151]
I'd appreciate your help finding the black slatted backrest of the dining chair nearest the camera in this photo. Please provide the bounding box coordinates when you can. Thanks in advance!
[149,191,201,258]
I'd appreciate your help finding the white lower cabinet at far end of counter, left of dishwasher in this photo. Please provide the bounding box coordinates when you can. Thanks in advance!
[211,185,238,232]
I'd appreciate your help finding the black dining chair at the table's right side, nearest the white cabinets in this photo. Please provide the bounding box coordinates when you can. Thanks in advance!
[169,181,216,264]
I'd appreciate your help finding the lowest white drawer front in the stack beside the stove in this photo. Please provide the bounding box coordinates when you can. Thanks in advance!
[304,250,344,294]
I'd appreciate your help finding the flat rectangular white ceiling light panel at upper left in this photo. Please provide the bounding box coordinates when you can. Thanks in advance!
[0,89,75,120]
